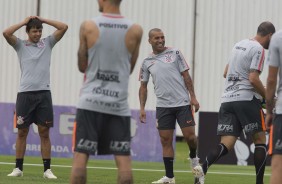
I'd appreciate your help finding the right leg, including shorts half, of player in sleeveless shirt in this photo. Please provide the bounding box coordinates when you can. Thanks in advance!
[107,114,133,184]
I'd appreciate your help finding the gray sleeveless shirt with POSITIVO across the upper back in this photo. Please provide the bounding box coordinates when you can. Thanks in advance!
[78,14,132,116]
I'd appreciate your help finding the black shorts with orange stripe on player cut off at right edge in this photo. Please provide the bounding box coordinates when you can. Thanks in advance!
[269,114,282,155]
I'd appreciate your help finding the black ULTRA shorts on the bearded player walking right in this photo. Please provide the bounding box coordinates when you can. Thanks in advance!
[217,98,266,137]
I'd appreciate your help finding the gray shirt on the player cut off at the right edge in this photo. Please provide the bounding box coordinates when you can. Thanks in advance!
[268,31,282,114]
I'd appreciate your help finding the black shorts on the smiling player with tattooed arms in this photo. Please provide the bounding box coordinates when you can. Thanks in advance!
[156,105,195,130]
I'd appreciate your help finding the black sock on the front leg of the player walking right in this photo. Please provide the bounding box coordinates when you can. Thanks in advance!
[254,144,266,184]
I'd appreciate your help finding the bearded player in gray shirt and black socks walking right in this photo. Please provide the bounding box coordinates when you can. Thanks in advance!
[193,22,275,184]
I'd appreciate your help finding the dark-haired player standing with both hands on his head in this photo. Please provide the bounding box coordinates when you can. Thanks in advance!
[3,16,68,179]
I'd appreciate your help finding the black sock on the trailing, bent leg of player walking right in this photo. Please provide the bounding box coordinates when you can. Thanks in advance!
[202,143,228,174]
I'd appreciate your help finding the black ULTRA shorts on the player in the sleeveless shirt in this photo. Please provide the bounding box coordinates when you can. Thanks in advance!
[73,109,131,155]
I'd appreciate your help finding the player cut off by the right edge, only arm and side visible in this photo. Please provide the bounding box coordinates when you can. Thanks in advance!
[265,30,282,184]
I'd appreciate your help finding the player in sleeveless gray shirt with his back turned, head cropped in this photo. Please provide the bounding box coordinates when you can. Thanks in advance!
[71,0,143,184]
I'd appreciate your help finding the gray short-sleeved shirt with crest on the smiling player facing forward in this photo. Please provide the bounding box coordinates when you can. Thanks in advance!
[140,48,190,107]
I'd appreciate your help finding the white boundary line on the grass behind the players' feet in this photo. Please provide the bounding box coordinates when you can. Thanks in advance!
[0,162,270,176]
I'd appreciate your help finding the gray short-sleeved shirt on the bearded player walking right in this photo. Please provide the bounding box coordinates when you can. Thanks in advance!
[221,39,264,103]
